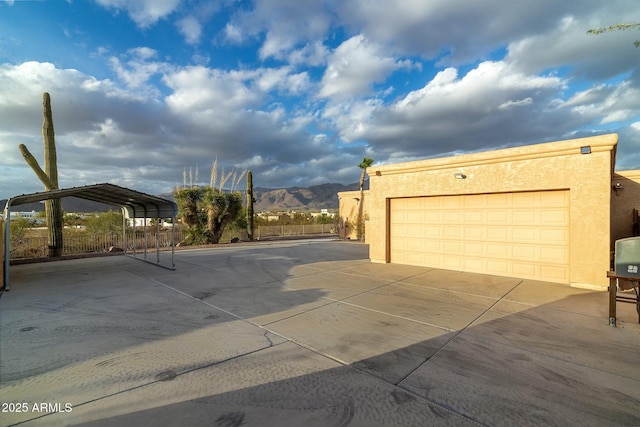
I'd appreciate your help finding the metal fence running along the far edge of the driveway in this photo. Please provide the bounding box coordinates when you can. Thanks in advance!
[11,224,337,260]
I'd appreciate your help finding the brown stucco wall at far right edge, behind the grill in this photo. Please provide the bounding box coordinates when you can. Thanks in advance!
[611,170,640,250]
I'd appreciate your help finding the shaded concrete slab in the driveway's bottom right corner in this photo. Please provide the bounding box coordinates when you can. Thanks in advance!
[400,334,640,427]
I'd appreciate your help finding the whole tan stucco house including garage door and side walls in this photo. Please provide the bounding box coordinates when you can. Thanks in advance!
[339,134,640,288]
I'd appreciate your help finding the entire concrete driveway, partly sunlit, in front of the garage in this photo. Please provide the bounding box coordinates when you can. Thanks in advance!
[0,239,640,427]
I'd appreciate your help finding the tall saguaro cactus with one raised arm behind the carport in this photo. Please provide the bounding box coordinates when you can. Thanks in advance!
[18,92,63,257]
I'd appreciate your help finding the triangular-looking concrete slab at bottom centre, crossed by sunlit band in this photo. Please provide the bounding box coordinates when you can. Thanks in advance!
[22,343,475,427]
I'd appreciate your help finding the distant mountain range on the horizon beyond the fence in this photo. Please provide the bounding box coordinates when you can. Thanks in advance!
[0,183,368,212]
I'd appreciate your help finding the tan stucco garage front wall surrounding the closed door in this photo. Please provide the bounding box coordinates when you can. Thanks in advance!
[367,134,618,286]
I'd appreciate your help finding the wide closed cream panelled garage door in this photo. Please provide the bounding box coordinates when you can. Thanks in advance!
[390,191,570,283]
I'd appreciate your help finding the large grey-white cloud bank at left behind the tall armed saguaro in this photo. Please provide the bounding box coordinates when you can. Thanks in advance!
[0,60,357,197]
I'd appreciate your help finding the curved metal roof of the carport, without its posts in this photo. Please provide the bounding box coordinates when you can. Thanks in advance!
[5,183,178,218]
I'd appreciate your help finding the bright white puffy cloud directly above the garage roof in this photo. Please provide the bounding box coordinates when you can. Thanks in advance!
[328,62,579,157]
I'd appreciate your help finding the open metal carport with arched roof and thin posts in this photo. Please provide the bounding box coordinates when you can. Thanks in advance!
[3,183,178,291]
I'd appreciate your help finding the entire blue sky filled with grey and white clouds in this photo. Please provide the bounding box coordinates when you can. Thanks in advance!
[0,0,640,198]
